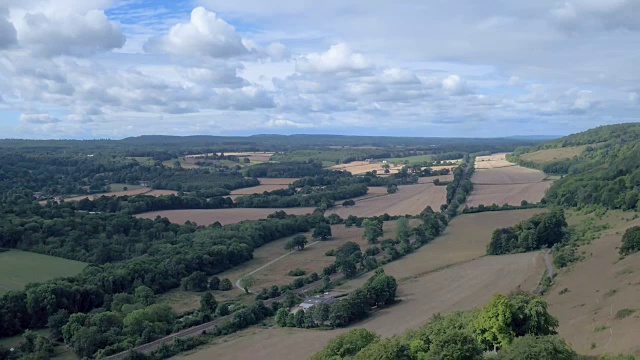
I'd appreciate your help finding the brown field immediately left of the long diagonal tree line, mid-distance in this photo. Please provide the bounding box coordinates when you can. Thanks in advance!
[327,184,447,218]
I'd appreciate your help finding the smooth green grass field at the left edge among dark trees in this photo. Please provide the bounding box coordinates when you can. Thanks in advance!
[0,250,87,294]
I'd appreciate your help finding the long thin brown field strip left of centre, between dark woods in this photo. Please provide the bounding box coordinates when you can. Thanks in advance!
[136,208,315,225]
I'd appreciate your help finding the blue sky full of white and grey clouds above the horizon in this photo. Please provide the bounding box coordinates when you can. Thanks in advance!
[0,0,640,139]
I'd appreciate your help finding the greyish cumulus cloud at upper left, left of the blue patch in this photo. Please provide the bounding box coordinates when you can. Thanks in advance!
[16,10,126,56]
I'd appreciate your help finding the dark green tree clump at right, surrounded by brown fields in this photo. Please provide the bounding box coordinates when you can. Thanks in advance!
[487,209,567,255]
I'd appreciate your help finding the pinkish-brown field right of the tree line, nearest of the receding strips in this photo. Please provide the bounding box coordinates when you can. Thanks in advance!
[466,181,553,207]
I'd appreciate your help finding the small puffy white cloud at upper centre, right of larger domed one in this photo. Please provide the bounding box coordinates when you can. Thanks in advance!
[296,43,372,73]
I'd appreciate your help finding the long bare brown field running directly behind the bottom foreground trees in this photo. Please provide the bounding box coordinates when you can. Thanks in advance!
[181,253,544,360]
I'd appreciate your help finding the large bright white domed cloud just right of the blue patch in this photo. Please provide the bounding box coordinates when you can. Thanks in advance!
[144,7,249,58]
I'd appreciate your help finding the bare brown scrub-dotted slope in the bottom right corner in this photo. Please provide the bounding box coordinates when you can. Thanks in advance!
[546,211,640,355]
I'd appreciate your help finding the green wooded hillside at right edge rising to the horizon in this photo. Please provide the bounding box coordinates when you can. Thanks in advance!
[511,123,640,210]
